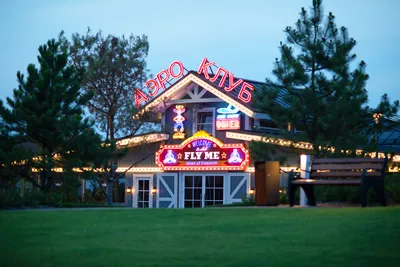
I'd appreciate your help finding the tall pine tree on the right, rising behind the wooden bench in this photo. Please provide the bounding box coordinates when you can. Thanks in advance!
[254,0,396,156]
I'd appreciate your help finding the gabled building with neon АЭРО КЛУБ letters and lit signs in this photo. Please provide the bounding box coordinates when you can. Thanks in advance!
[117,58,298,208]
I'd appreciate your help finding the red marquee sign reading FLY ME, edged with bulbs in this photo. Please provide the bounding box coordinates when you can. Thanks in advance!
[156,131,250,171]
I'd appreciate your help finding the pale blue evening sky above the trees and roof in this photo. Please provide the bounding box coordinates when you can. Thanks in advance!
[0,0,400,107]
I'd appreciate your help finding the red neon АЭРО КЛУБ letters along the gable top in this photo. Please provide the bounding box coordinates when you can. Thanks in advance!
[135,58,254,108]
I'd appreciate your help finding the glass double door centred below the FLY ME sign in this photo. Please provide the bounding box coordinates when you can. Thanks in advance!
[184,174,224,208]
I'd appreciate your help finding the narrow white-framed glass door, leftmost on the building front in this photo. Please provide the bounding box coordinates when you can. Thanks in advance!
[132,177,153,208]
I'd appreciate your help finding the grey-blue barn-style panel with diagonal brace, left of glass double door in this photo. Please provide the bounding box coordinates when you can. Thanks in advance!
[156,173,178,208]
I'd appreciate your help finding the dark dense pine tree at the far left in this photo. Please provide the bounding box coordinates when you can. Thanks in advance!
[0,39,102,190]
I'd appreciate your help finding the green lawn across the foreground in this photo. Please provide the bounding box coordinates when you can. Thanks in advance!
[0,207,400,267]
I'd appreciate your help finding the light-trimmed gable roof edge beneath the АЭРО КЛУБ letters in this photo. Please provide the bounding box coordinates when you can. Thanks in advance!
[139,71,269,119]
